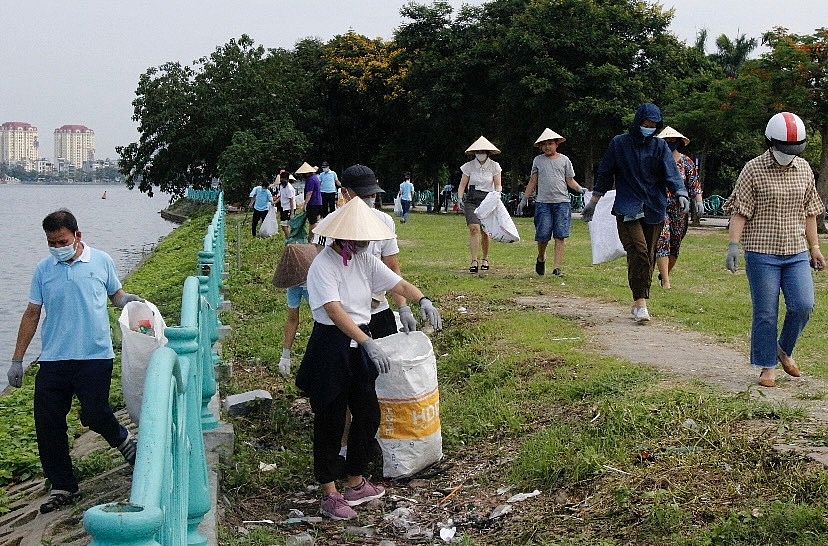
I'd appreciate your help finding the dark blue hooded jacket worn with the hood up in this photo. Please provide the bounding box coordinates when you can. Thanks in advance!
[593,102,687,224]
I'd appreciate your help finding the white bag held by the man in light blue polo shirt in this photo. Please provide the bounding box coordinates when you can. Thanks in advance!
[118,301,167,425]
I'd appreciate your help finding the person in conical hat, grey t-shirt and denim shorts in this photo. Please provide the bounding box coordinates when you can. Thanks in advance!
[518,128,586,277]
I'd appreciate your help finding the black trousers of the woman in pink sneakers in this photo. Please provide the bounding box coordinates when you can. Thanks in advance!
[313,347,380,483]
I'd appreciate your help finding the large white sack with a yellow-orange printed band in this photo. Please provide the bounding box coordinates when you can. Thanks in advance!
[376,331,443,478]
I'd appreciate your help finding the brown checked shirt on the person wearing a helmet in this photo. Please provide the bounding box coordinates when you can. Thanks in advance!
[724,150,825,256]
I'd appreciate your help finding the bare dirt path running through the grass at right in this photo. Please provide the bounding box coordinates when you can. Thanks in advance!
[516,294,828,466]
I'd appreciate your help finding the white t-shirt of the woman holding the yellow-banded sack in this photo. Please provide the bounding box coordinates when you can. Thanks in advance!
[308,246,402,325]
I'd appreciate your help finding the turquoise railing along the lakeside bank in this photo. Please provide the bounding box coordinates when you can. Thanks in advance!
[83,190,224,546]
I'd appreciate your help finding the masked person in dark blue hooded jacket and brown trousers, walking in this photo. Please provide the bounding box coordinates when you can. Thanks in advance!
[581,103,690,324]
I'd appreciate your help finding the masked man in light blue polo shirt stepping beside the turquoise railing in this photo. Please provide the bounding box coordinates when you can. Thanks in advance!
[8,209,143,514]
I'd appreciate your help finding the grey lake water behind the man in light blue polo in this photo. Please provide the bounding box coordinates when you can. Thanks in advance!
[0,184,179,392]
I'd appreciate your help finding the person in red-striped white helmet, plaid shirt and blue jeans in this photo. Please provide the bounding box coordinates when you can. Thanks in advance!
[725,112,825,387]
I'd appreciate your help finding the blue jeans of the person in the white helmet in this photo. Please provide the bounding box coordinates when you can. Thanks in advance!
[745,252,814,368]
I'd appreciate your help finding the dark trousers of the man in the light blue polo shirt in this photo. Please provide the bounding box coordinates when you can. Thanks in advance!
[34,358,128,492]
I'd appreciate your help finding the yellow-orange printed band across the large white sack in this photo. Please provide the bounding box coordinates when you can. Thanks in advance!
[379,389,440,440]
